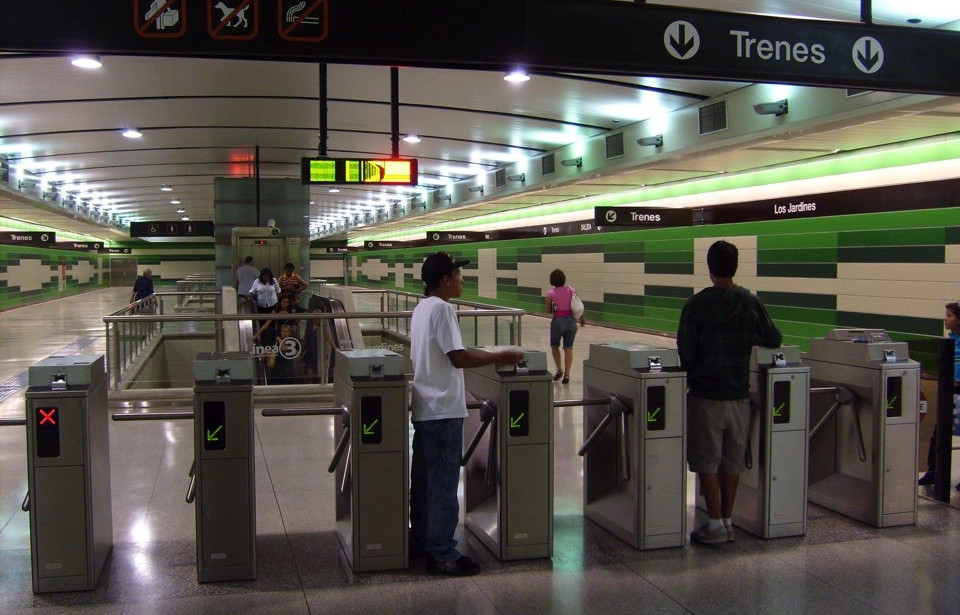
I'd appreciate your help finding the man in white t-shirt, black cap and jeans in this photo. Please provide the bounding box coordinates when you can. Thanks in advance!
[410,252,523,576]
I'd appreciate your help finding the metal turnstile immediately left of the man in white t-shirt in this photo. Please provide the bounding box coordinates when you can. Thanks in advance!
[329,349,410,572]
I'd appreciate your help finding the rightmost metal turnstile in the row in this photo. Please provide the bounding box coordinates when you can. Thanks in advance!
[804,329,920,527]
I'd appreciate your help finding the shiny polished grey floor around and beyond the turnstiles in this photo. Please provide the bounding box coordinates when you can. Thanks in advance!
[0,289,960,615]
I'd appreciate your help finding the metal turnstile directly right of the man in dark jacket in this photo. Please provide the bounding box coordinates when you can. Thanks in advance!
[733,346,810,538]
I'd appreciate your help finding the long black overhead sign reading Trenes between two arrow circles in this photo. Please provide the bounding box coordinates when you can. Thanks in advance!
[0,0,960,96]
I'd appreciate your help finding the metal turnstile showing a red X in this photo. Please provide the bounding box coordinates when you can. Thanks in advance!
[25,355,113,594]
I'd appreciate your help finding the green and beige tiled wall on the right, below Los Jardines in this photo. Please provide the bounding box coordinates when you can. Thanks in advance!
[351,209,960,366]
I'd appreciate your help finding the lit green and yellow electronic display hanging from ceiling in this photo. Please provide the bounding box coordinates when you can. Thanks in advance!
[300,158,417,186]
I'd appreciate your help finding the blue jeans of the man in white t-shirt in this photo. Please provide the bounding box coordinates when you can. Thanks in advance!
[410,419,463,562]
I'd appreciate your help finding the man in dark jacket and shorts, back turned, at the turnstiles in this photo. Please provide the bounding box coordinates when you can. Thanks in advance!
[677,240,783,544]
